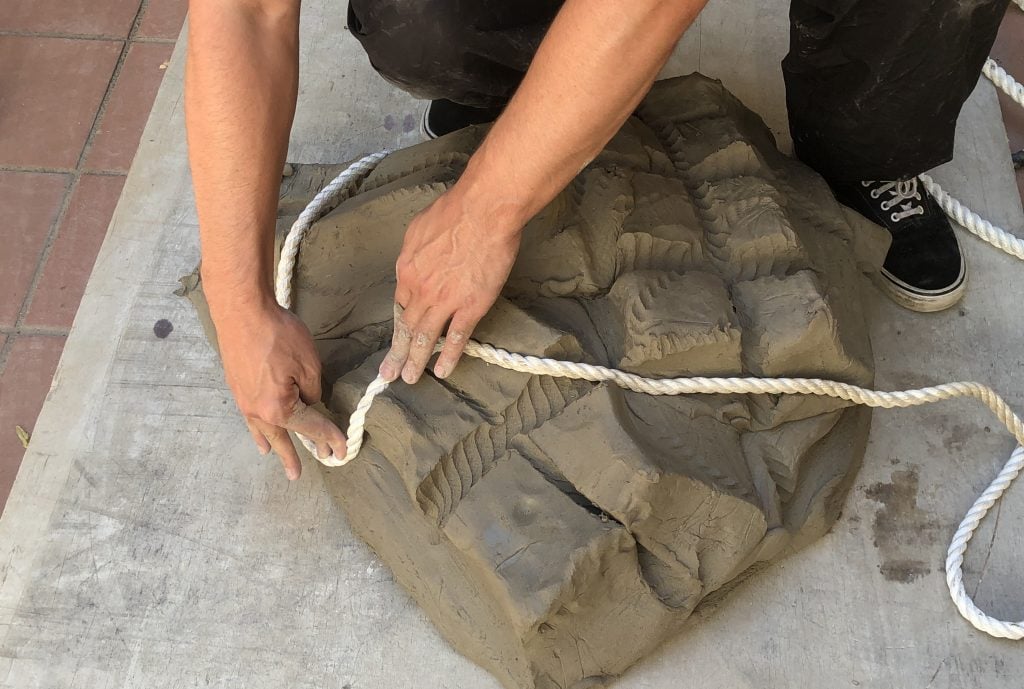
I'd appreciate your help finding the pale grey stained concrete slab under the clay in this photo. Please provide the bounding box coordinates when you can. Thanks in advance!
[0,0,1024,689]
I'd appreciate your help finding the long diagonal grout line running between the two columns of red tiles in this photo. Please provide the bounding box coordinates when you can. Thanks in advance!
[0,0,155,376]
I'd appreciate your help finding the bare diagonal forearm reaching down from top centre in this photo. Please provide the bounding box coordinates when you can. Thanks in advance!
[455,0,707,231]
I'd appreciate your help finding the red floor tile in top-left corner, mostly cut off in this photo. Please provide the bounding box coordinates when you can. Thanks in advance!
[0,0,141,38]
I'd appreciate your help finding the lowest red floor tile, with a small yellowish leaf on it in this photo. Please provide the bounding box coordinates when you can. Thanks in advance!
[0,335,66,508]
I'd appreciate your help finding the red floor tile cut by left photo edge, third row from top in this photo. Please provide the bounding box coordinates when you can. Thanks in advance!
[0,172,69,328]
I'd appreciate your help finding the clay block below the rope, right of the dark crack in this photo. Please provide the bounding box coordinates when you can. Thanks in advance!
[531,385,765,593]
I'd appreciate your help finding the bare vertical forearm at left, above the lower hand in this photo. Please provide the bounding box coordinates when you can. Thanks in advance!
[185,0,299,320]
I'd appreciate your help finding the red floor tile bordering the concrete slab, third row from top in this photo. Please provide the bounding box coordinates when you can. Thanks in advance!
[26,175,125,328]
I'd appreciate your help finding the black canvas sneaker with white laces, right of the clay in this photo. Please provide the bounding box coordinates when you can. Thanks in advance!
[831,177,967,312]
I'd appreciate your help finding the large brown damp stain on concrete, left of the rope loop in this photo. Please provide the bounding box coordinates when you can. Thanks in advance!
[864,466,940,584]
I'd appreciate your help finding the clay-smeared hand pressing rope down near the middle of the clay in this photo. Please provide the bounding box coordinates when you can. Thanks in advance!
[380,187,521,384]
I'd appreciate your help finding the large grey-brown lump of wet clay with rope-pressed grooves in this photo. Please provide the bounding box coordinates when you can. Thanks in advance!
[184,76,886,689]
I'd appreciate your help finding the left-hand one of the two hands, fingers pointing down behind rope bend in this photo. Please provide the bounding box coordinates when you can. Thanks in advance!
[215,305,345,480]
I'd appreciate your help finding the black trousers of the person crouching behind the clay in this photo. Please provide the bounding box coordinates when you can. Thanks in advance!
[348,0,1009,180]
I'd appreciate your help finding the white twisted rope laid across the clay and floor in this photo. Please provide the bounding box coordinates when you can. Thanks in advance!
[274,45,1024,640]
